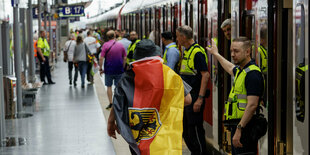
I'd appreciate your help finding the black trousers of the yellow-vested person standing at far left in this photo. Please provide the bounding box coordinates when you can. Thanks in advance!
[38,56,53,83]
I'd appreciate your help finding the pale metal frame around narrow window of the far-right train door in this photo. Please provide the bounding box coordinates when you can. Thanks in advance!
[292,0,309,154]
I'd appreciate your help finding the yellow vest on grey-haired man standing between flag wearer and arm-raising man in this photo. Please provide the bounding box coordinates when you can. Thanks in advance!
[180,43,208,75]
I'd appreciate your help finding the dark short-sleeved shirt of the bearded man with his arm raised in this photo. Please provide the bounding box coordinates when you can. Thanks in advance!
[233,60,264,97]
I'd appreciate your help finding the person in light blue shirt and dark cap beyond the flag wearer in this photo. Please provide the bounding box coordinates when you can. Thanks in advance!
[161,32,181,73]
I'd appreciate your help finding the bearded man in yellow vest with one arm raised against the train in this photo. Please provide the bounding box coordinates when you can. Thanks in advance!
[206,37,264,155]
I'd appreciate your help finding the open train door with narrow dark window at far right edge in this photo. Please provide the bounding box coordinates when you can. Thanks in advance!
[293,0,309,155]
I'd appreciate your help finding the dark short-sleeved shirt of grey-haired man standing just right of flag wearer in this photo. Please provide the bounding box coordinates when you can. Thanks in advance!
[181,43,208,93]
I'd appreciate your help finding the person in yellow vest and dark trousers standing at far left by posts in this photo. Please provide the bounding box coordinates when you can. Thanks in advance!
[37,30,55,85]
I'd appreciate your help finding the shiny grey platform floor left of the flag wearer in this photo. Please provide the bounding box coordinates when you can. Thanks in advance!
[0,62,115,155]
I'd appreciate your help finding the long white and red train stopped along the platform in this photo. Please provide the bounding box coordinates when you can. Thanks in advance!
[87,0,309,155]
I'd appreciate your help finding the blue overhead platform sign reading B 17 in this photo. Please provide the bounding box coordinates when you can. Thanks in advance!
[58,5,85,17]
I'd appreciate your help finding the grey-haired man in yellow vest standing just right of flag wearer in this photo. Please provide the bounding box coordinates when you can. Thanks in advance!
[176,25,210,155]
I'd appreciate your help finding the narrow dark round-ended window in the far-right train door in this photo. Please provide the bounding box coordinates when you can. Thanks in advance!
[295,63,308,122]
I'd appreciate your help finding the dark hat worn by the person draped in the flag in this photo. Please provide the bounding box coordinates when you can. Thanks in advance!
[133,39,161,60]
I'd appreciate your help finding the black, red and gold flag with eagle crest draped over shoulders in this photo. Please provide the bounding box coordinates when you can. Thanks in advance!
[113,59,184,155]
